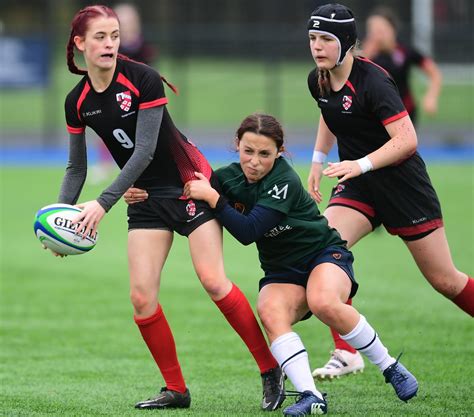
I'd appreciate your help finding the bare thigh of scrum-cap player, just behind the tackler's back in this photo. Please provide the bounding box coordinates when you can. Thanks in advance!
[324,206,372,248]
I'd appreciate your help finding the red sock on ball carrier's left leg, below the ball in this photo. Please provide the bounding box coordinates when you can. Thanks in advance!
[134,304,186,392]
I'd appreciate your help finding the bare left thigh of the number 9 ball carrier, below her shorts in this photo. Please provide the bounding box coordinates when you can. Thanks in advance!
[128,229,173,297]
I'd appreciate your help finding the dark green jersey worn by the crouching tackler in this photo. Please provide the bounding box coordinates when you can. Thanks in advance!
[216,157,345,271]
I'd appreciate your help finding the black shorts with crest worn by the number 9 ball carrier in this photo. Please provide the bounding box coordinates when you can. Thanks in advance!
[127,193,215,236]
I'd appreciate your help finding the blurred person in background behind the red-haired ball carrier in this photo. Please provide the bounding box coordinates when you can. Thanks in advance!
[91,3,156,183]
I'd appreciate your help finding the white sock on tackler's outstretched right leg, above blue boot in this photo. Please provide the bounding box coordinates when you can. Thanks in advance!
[341,314,395,372]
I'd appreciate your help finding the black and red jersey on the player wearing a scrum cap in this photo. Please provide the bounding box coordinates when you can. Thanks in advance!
[308,58,407,161]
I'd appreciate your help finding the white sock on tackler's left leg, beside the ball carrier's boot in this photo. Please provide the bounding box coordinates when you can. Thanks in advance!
[270,332,323,399]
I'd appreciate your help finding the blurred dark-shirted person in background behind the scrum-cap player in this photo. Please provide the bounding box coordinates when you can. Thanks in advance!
[363,7,441,124]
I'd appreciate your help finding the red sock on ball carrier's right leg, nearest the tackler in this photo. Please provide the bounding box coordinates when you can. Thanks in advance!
[215,284,278,374]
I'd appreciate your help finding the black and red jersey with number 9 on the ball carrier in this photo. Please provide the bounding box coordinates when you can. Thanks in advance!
[65,59,211,188]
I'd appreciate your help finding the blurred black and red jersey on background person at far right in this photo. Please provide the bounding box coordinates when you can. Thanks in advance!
[372,44,427,113]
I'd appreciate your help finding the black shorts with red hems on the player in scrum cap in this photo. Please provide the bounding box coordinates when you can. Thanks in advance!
[328,153,443,240]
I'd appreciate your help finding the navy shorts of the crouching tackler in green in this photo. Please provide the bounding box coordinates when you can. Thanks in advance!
[259,246,359,320]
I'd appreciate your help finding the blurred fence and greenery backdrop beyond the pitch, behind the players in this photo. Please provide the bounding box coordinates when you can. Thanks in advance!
[0,0,474,155]
